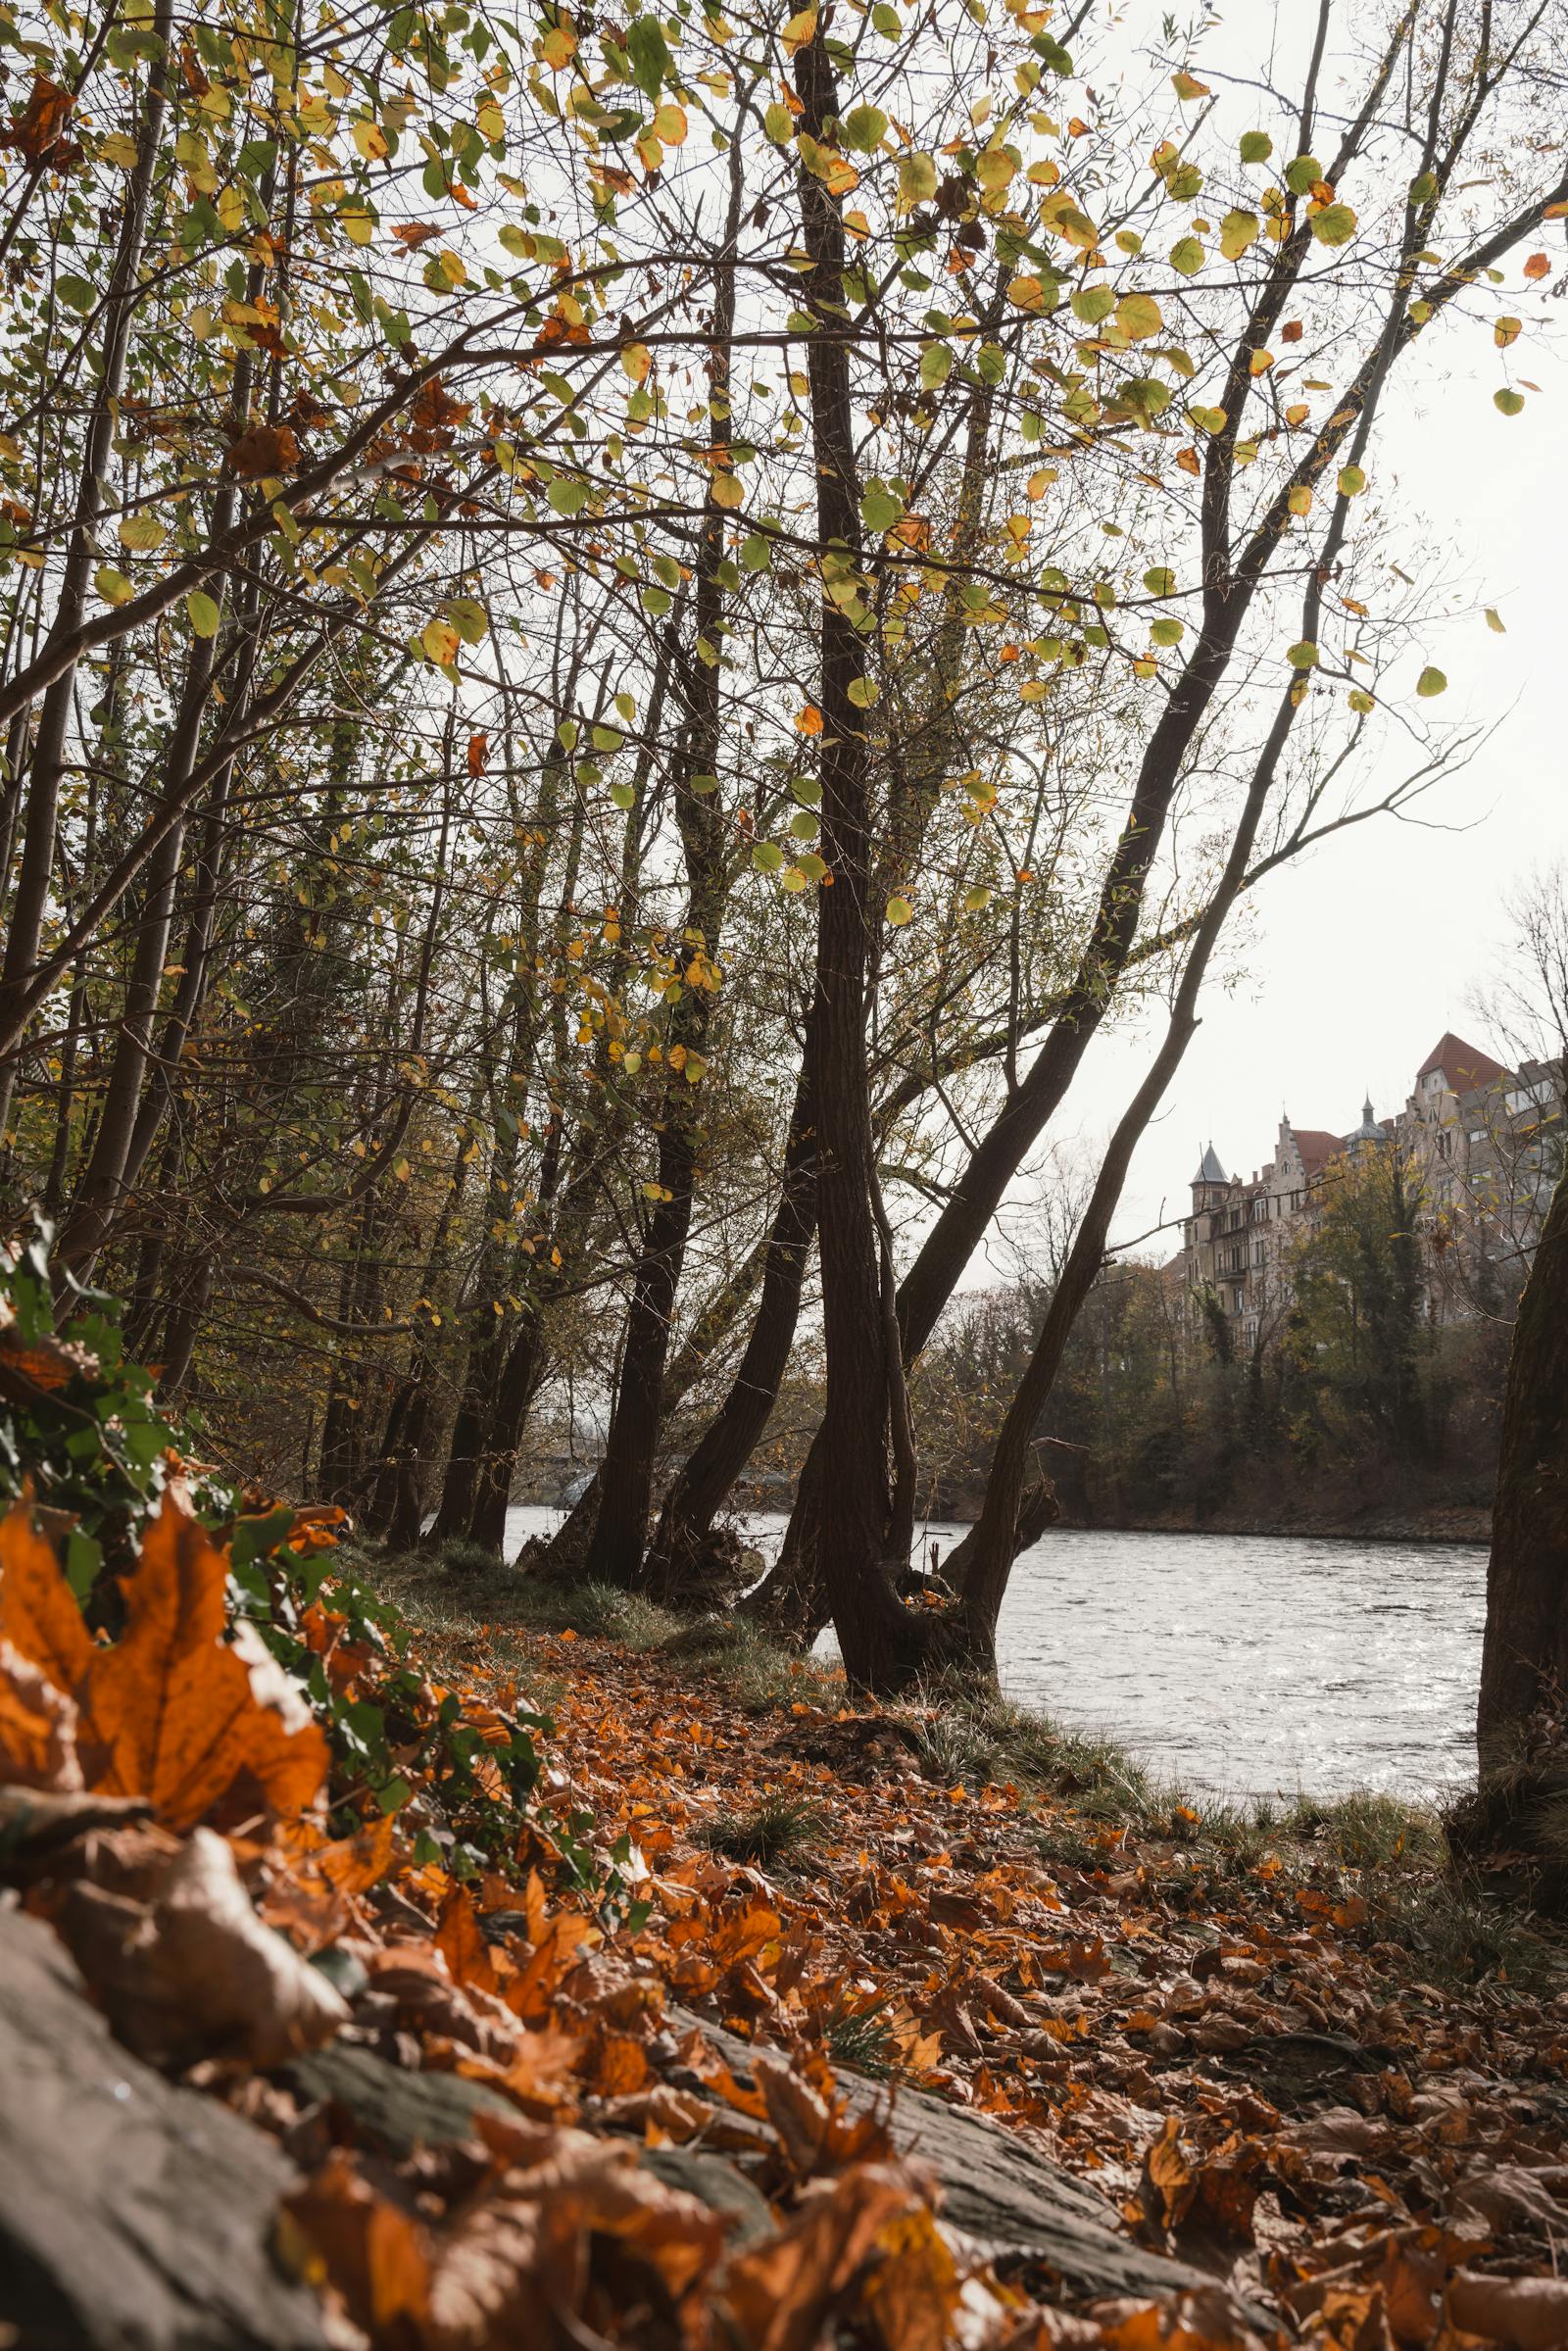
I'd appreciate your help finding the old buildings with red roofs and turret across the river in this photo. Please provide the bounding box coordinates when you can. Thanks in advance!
[1178,1032,1563,1354]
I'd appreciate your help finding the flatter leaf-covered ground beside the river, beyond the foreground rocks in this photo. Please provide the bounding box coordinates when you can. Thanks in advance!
[321,1563,1568,2351]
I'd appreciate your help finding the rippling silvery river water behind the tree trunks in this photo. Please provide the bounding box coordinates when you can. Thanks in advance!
[511,1509,1486,1796]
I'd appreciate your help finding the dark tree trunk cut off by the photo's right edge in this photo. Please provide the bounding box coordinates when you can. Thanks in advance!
[1476,1156,1568,1778]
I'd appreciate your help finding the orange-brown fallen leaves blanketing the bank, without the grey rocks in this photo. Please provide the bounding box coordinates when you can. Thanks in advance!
[0,1495,1568,2351]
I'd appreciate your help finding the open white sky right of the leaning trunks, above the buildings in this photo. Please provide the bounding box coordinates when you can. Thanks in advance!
[992,0,1568,1281]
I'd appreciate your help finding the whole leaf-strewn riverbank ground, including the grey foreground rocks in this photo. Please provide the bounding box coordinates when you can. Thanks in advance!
[0,1544,1568,2351]
